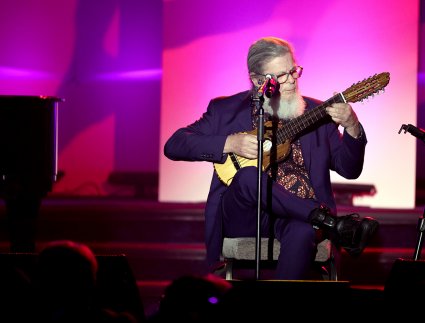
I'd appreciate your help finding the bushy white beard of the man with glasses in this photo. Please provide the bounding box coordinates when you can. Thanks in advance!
[263,93,307,120]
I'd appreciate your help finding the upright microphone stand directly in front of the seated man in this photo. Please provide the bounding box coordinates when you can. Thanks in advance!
[253,93,264,280]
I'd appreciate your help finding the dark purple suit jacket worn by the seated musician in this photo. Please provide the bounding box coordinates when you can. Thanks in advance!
[164,91,367,265]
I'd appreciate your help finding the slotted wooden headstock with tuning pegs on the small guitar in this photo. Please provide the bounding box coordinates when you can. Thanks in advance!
[342,72,390,102]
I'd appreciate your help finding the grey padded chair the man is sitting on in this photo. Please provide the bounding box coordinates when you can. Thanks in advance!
[222,237,338,281]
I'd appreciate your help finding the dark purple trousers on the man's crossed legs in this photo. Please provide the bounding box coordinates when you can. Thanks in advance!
[222,167,320,280]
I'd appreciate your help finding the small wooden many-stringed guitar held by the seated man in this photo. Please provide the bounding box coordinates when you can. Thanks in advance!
[214,72,390,185]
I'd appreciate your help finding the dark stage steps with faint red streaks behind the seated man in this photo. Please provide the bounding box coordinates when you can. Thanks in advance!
[0,197,424,314]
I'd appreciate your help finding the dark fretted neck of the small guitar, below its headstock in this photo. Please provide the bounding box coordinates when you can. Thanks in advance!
[276,93,345,144]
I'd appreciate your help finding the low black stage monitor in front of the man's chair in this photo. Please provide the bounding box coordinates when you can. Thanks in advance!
[222,280,351,322]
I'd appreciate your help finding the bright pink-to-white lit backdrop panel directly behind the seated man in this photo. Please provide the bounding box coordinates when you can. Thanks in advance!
[159,0,419,208]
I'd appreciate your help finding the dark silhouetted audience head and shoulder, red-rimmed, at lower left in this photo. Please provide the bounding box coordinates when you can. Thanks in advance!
[34,240,140,323]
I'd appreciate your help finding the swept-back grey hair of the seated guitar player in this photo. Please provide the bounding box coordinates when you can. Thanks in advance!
[247,37,295,74]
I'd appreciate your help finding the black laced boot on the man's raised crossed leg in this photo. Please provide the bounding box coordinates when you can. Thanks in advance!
[309,205,379,257]
